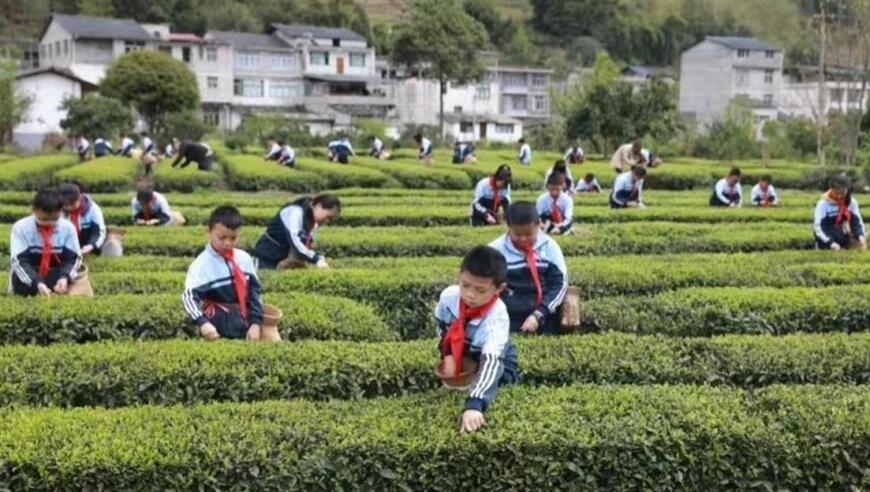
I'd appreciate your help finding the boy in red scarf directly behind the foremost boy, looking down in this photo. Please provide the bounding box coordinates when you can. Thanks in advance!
[489,202,568,334]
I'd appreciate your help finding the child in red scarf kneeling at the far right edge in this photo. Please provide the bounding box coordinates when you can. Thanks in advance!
[813,176,867,249]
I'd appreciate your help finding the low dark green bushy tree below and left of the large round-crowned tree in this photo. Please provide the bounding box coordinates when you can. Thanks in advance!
[60,94,133,138]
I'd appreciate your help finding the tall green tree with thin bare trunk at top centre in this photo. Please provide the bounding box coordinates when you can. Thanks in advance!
[393,0,488,136]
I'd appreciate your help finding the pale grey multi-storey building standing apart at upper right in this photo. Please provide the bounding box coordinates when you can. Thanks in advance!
[679,36,783,128]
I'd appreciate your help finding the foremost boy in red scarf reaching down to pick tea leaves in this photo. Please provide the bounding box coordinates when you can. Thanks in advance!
[435,246,518,432]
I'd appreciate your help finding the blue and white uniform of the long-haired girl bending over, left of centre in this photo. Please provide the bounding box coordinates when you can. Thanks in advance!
[254,198,321,269]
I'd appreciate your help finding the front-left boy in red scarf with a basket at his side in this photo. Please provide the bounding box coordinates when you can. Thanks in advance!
[181,206,263,340]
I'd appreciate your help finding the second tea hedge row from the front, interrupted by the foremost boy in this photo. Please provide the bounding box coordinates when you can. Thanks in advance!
[0,333,870,407]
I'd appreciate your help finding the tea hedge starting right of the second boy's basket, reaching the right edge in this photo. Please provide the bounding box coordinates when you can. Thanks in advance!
[582,285,870,337]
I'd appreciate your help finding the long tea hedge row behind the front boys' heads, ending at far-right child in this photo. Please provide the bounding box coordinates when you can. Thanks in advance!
[0,222,813,258]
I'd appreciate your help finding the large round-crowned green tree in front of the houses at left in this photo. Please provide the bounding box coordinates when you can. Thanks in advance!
[100,51,199,134]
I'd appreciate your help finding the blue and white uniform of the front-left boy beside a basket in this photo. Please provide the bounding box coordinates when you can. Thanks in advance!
[181,244,263,338]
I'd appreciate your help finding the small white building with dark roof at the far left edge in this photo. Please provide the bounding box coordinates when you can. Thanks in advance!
[12,67,97,152]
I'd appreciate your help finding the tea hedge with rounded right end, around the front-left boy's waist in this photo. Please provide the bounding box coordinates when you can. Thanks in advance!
[0,291,397,344]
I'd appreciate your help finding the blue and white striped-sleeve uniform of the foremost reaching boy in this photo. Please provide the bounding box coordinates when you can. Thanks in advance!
[435,285,519,412]
